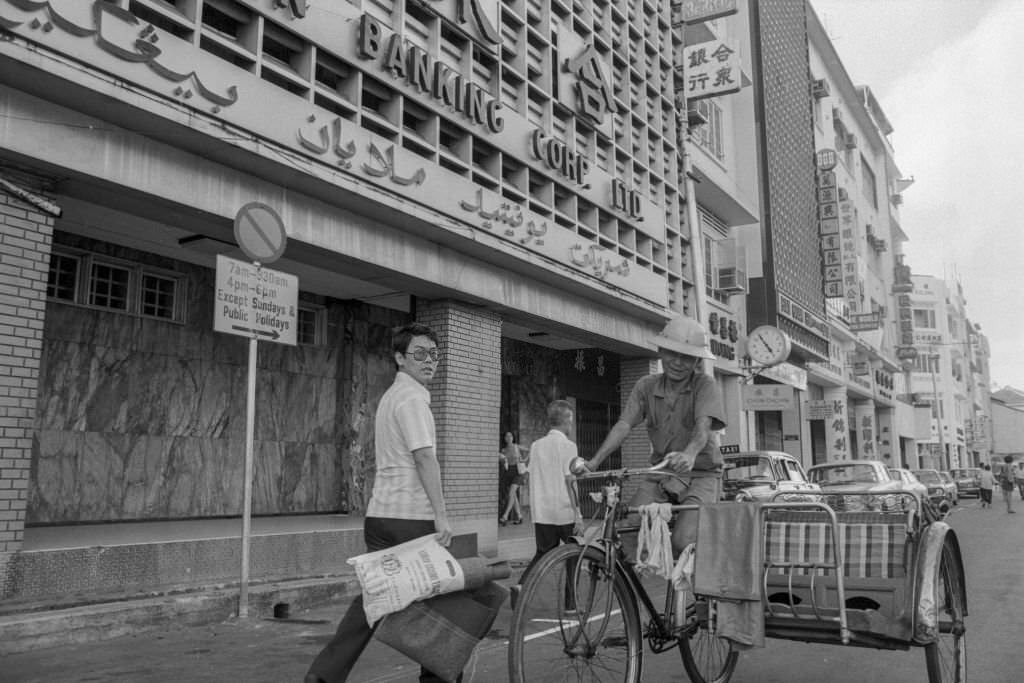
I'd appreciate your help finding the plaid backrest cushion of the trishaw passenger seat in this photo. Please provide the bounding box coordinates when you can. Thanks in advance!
[765,512,907,579]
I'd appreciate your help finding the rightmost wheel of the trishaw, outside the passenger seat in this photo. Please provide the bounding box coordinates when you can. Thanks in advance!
[925,543,967,683]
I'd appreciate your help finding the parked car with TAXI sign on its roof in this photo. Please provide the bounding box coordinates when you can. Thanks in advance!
[722,451,821,502]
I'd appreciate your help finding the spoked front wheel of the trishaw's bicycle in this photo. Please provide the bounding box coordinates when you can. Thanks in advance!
[509,544,643,683]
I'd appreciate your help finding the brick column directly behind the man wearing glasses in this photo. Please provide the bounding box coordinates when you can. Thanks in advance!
[416,300,502,524]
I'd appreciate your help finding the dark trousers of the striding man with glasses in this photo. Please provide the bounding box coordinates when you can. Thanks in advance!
[309,517,462,683]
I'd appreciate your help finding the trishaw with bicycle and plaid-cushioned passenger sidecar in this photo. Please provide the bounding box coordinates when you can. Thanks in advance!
[509,467,967,683]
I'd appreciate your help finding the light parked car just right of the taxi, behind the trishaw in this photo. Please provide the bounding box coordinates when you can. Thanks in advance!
[807,460,904,512]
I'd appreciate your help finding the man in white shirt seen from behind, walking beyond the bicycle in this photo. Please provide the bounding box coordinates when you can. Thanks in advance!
[519,400,583,585]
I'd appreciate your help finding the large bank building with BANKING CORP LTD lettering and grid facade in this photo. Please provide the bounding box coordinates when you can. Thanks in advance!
[0,0,758,598]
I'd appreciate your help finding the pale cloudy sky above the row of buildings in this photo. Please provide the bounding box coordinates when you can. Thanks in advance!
[811,0,1024,389]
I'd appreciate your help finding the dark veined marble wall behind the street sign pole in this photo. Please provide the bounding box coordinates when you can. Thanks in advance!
[29,235,409,524]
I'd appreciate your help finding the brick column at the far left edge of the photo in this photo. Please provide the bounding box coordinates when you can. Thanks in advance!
[0,189,53,598]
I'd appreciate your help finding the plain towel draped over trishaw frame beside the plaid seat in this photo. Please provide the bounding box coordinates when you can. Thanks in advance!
[693,503,765,647]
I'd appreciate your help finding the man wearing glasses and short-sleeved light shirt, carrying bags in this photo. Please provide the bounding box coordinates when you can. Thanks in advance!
[305,324,462,683]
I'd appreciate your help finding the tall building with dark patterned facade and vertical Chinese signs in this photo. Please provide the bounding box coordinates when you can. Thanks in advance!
[748,1,912,465]
